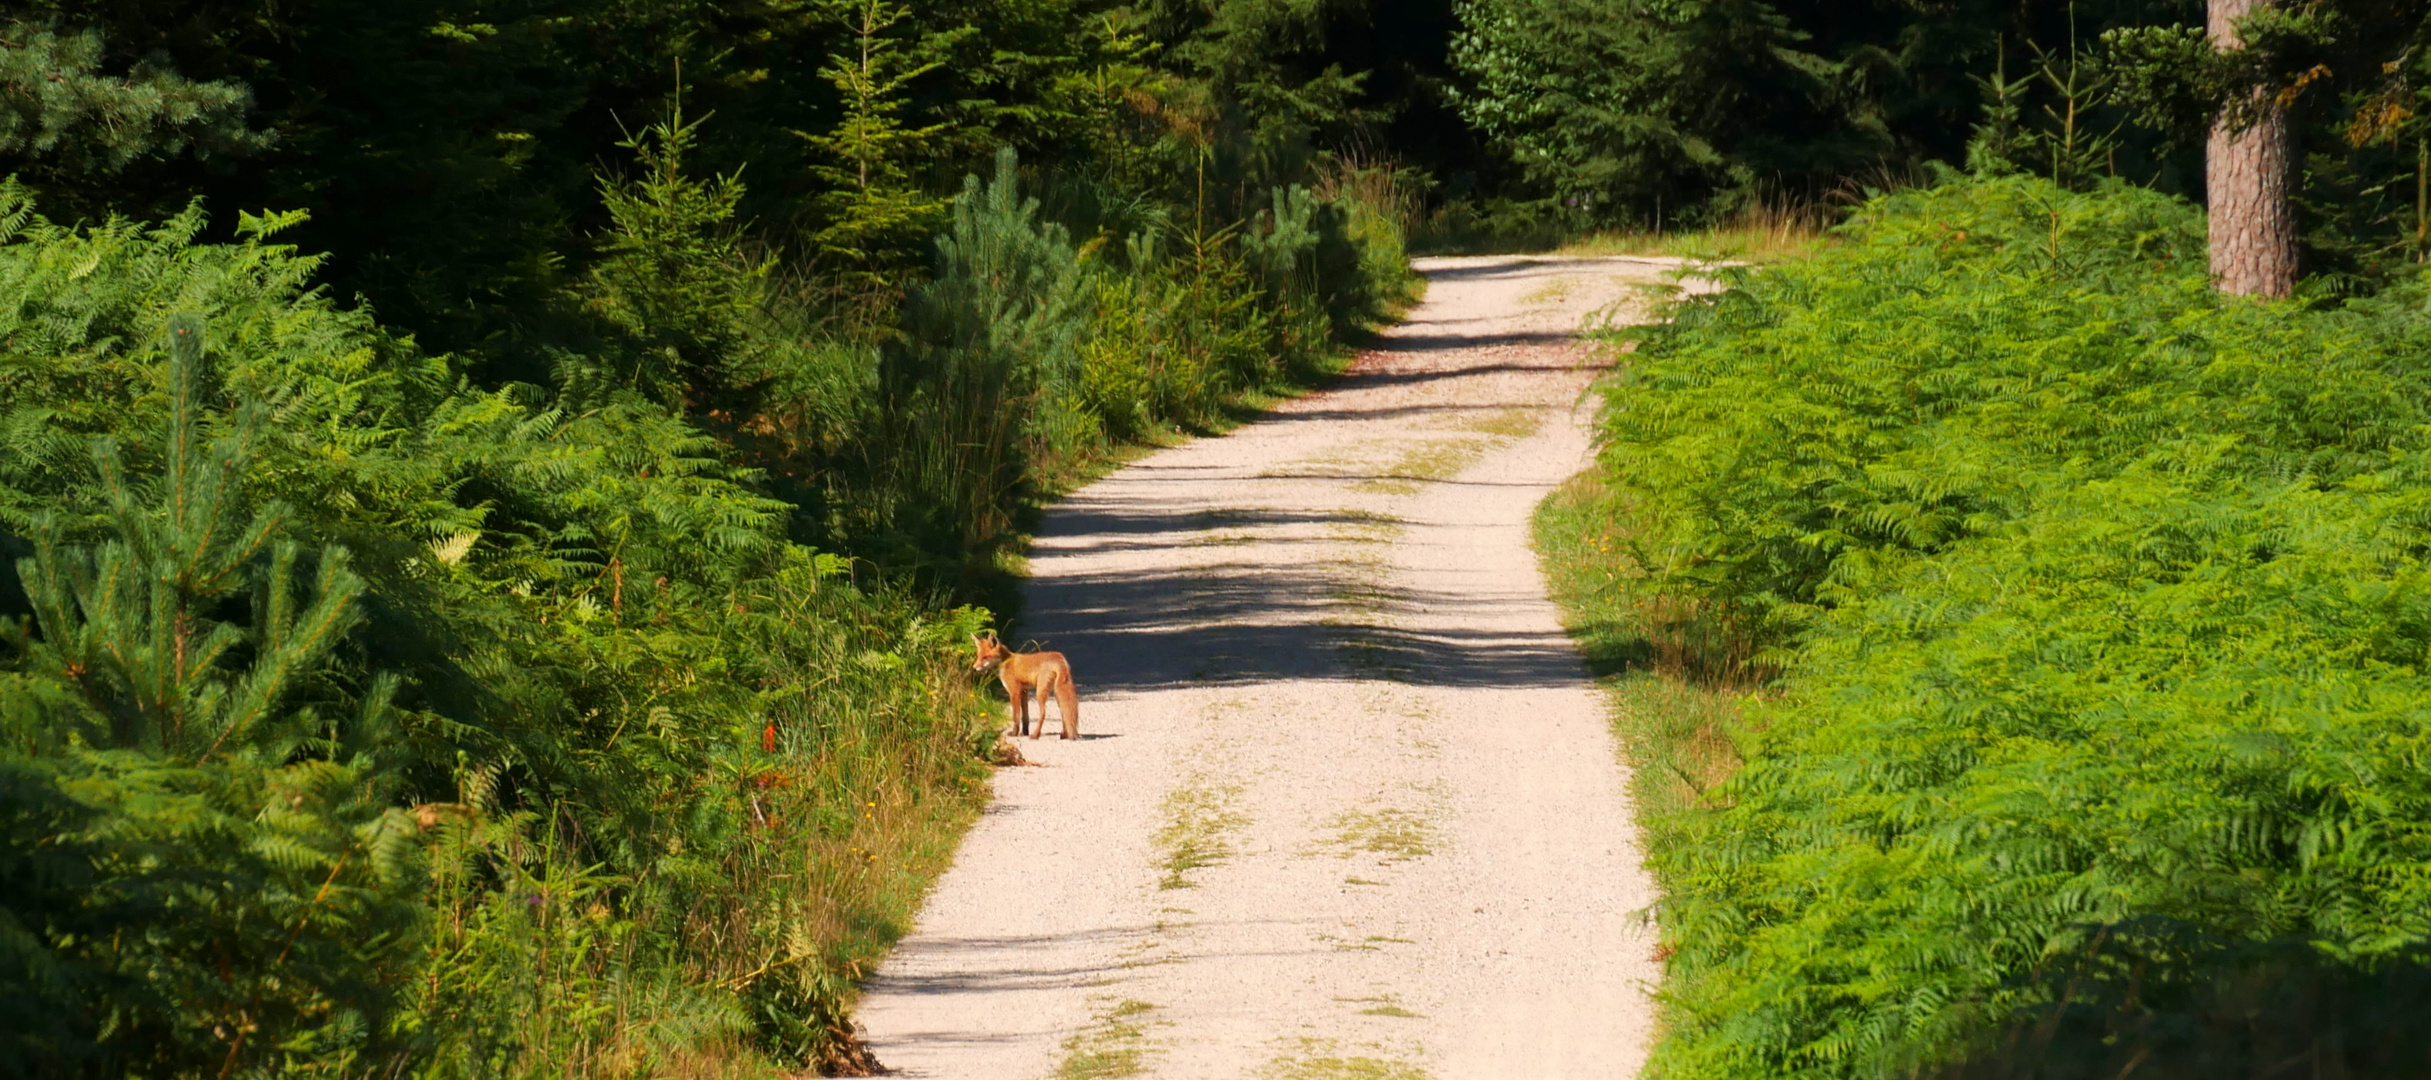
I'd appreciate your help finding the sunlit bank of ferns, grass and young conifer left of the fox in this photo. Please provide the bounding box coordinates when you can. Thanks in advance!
[0,192,987,1075]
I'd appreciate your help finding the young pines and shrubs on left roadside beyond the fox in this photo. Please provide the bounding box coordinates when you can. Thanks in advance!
[834,151,1408,589]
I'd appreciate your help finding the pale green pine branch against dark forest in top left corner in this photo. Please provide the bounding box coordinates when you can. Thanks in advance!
[0,22,272,173]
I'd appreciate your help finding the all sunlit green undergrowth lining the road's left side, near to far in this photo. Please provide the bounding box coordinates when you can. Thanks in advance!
[0,124,1408,1078]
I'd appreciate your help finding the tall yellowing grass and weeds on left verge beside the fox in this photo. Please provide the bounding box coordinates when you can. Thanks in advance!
[408,572,999,1080]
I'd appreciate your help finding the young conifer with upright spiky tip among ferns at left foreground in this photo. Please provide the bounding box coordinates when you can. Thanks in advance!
[0,316,418,1075]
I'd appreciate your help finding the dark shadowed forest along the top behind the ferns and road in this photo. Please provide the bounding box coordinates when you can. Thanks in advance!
[15,0,2424,340]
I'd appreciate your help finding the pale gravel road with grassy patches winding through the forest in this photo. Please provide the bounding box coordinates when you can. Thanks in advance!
[861,258,1670,1080]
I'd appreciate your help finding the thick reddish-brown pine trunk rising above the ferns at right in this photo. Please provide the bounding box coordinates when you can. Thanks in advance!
[2202,0,2295,297]
